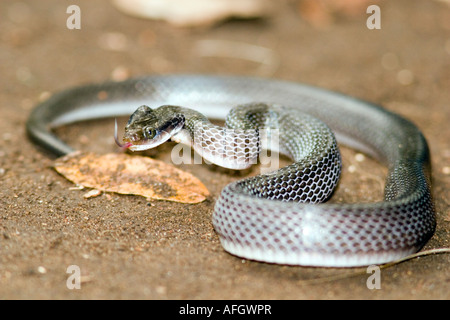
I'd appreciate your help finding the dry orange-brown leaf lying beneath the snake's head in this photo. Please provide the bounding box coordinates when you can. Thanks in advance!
[55,152,209,203]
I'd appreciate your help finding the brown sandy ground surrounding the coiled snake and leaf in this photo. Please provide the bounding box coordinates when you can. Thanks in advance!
[0,0,450,299]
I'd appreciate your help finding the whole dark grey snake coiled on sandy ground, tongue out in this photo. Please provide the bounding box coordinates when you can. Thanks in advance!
[26,74,436,267]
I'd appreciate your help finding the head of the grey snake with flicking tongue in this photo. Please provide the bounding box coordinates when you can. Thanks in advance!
[115,105,185,151]
